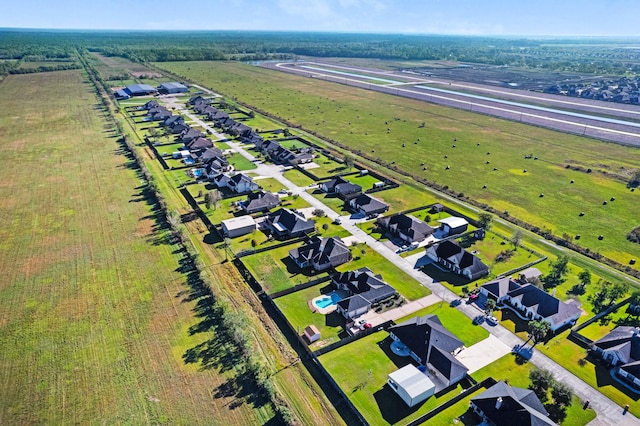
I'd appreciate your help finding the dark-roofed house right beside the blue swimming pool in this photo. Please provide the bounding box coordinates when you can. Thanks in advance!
[332,267,397,320]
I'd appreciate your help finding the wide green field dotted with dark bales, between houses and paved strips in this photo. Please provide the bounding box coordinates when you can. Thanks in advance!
[159,62,640,268]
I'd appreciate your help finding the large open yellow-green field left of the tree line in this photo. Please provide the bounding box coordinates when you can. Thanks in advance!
[0,70,272,425]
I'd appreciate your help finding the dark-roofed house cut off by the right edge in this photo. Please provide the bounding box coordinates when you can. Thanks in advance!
[591,326,640,392]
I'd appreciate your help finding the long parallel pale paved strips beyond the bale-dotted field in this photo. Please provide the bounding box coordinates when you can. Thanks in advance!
[261,62,640,146]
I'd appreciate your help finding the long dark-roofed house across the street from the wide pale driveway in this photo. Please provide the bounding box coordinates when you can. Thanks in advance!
[480,277,582,332]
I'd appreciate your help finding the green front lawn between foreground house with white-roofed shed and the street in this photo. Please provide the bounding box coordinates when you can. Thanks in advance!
[395,303,489,347]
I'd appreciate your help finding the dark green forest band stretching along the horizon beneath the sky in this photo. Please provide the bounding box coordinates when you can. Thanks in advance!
[0,29,640,76]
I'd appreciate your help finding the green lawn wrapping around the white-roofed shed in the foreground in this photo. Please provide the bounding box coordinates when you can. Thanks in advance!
[319,331,472,425]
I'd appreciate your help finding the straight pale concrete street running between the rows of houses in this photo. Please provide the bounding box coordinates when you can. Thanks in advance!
[174,98,640,426]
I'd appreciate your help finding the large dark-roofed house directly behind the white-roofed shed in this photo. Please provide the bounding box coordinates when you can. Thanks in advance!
[388,314,468,391]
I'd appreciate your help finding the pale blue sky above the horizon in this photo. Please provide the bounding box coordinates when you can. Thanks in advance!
[5,0,640,36]
